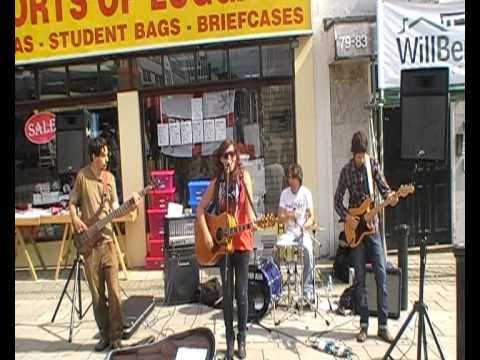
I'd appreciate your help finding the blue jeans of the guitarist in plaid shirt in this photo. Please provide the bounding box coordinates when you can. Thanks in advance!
[350,232,388,329]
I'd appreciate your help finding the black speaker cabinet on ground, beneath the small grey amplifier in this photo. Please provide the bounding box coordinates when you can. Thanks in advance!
[164,256,200,305]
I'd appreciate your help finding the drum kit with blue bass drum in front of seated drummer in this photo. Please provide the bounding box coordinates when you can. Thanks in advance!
[248,225,325,325]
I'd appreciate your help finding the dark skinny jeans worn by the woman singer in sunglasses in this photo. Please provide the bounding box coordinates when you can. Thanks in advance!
[219,251,250,340]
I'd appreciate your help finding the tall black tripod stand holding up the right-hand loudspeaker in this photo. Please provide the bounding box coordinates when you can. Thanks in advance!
[383,164,445,360]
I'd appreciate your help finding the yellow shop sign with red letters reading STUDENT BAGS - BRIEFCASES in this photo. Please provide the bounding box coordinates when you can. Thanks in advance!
[15,0,312,65]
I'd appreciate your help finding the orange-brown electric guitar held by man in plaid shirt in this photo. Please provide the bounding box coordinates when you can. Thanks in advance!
[345,184,415,248]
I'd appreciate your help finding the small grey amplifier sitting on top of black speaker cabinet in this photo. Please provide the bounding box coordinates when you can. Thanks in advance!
[165,215,195,255]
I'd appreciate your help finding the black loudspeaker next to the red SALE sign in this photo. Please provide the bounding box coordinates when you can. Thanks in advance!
[56,129,88,174]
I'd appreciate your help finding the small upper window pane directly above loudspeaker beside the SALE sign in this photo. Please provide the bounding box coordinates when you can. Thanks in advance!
[68,63,98,96]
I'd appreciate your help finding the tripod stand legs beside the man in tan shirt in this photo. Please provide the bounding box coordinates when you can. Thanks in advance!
[52,252,92,342]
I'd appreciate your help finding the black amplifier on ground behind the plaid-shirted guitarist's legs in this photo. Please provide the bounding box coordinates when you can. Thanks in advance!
[365,264,402,319]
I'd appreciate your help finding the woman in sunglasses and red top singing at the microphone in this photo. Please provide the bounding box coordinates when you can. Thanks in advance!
[196,140,255,360]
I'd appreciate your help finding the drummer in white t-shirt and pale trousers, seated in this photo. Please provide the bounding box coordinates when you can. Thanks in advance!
[277,164,315,303]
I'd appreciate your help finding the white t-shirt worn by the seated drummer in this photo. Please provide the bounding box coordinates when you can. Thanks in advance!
[279,185,313,233]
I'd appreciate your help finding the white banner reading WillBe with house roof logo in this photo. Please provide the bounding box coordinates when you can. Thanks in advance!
[377,0,465,89]
